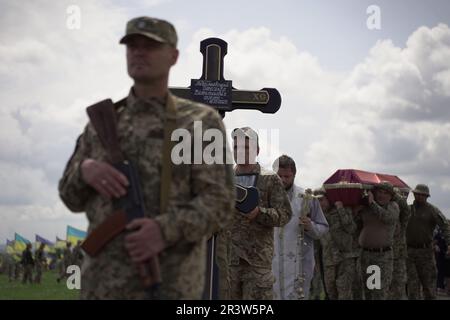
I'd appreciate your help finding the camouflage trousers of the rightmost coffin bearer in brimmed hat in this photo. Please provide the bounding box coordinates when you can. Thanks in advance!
[406,247,437,300]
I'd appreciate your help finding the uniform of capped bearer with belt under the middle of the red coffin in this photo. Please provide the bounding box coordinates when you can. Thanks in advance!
[356,201,400,300]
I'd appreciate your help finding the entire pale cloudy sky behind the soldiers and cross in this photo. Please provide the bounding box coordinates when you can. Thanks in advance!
[0,0,450,243]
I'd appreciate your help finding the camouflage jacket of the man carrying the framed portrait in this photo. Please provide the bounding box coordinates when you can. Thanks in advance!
[230,164,292,269]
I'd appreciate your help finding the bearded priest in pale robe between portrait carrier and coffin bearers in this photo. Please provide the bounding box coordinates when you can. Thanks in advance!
[272,155,328,300]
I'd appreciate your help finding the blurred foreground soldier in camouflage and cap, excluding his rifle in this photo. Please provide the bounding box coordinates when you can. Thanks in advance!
[59,17,235,299]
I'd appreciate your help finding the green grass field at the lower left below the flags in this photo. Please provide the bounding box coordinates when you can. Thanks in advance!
[0,271,79,300]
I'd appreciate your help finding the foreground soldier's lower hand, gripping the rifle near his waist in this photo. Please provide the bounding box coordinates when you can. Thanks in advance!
[125,218,165,263]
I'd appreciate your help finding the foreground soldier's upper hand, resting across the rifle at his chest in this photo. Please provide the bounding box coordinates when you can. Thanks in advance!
[81,159,128,199]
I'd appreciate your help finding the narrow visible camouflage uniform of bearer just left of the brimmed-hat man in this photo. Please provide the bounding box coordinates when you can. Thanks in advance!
[389,193,411,300]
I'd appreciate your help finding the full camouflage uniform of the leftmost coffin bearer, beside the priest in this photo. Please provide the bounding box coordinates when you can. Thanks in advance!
[320,207,356,300]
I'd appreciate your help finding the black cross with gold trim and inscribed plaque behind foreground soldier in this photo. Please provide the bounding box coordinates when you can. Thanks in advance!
[170,38,281,116]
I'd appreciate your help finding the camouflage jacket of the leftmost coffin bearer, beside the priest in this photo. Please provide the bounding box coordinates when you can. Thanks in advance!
[320,207,357,266]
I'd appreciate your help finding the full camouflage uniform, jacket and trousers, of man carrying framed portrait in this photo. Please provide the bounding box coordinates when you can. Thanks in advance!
[229,164,292,300]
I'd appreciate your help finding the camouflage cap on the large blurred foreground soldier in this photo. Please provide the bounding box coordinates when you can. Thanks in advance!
[120,17,178,47]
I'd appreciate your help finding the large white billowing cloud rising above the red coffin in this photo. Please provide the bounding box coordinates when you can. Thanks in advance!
[308,24,450,214]
